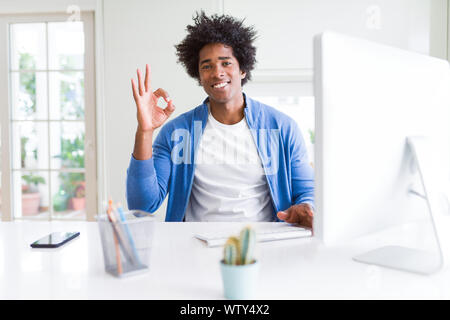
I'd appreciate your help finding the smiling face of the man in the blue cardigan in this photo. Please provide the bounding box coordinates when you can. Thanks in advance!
[198,43,245,104]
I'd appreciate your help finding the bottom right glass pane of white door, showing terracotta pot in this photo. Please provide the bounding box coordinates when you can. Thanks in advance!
[51,172,86,220]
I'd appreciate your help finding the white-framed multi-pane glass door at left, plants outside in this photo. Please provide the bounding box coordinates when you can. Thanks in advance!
[2,13,97,220]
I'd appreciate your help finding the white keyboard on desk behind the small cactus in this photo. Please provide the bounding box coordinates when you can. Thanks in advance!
[194,222,312,247]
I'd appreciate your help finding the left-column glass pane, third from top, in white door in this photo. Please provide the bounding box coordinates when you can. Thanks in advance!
[12,121,48,169]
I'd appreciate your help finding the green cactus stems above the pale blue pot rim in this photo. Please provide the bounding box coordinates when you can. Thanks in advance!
[223,226,256,265]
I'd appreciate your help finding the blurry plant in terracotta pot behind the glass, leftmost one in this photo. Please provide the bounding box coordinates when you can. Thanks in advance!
[22,173,45,216]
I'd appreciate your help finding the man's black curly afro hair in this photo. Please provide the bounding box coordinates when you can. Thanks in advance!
[175,11,256,85]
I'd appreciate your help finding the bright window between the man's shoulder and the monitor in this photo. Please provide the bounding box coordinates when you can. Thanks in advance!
[244,80,315,165]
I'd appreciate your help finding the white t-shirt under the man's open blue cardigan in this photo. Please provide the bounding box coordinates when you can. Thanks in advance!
[185,106,273,221]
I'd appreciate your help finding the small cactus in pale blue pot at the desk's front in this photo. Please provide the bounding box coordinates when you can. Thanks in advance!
[220,226,259,299]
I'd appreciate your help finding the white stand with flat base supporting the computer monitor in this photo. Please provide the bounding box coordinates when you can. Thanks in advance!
[353,137,450,275]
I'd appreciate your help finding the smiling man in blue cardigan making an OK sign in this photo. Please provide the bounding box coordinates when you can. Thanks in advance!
[127,12,314,228]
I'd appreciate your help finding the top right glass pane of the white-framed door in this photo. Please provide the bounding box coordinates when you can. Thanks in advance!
[48,21,84,70]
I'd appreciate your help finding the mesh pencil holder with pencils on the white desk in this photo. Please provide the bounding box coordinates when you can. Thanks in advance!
[97,210,155,277]
